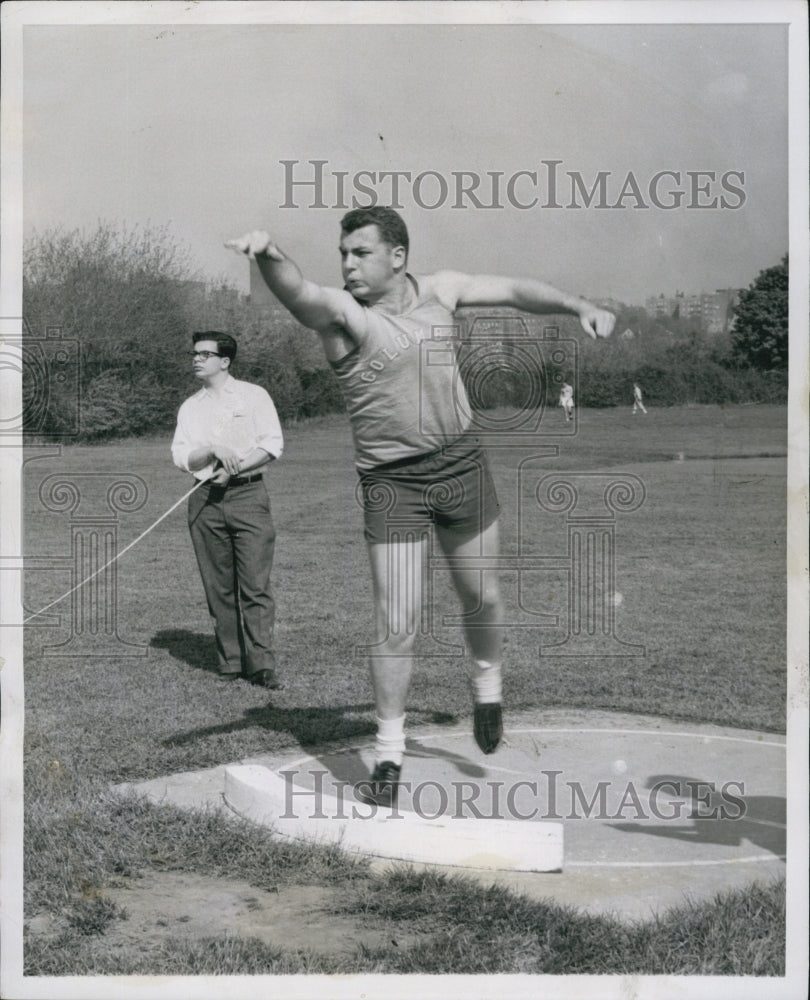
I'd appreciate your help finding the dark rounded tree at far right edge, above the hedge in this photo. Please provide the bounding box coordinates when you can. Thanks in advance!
[731,254,788,371]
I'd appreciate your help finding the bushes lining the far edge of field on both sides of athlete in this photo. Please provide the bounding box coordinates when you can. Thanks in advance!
[23,229,787,440]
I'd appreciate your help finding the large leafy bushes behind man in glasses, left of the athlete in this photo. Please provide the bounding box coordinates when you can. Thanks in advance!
[23,222,343,440]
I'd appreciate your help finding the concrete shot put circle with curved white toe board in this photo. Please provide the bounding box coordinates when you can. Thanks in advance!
[225,723,786,877]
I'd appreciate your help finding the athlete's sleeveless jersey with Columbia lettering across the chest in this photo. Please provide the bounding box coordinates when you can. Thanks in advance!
[331,275,472,471]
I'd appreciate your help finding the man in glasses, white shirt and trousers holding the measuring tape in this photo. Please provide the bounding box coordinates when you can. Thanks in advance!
[172,331,284,689]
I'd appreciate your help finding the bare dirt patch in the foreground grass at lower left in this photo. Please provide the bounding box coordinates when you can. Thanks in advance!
[28,872,418,955]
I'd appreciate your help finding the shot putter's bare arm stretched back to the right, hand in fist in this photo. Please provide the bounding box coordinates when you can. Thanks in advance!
[433,271,616,339]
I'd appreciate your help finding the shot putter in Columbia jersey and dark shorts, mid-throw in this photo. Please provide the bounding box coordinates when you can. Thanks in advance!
[227,207,614,806]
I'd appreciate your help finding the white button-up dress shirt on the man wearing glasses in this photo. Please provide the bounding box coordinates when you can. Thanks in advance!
[172,375,284,479]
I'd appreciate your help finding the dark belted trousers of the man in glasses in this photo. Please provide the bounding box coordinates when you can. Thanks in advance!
[188,479,276,677]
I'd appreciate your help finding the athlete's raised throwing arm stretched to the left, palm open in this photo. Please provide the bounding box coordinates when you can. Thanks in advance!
[225,229,354,332]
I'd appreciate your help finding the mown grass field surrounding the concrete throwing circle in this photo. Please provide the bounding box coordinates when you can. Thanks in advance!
[19,406,786,975]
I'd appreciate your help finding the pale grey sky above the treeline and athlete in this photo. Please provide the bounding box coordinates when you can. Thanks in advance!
[23,13,788,304]
